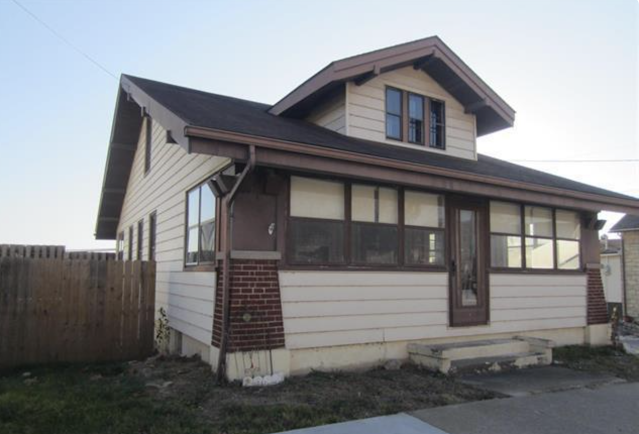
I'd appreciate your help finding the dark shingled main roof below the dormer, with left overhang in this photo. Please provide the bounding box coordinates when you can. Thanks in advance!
[96,75,639,239]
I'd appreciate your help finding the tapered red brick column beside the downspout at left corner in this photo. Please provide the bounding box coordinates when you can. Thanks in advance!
[212,259,284,353]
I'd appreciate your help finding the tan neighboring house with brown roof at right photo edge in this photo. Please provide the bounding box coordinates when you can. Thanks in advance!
[610,213,639,319]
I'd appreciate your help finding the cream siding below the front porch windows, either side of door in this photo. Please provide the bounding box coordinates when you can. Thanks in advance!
[280,271,586,350]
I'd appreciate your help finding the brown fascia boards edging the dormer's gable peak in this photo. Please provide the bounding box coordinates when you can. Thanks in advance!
[269,36,515,133]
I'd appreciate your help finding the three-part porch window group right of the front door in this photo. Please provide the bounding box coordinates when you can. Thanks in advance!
[490,202,581,270]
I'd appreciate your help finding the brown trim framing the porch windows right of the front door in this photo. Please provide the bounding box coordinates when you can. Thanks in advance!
[488,199,585,274]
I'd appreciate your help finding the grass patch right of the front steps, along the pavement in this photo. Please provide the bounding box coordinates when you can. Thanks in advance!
[553,345,639,381]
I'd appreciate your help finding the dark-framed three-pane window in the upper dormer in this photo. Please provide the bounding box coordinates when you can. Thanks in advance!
[386,87,446,150]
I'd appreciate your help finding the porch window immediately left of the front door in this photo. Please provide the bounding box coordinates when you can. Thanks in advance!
[404,190,446,266]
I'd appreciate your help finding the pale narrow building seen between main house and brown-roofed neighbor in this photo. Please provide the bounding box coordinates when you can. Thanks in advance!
[601,235,623,317]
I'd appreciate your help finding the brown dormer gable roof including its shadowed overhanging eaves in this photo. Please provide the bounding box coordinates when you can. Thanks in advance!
[269,36,515,136]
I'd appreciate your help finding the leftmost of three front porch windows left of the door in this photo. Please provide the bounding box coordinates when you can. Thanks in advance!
[289,176,345,264]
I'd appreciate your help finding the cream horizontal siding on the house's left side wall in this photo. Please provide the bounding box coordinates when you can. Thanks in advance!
[118,118,227,345]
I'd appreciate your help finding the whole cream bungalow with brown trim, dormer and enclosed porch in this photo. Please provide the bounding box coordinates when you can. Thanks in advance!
[96,37,639,378]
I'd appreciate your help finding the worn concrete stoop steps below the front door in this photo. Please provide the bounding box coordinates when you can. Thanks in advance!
[408,336,555,374]
